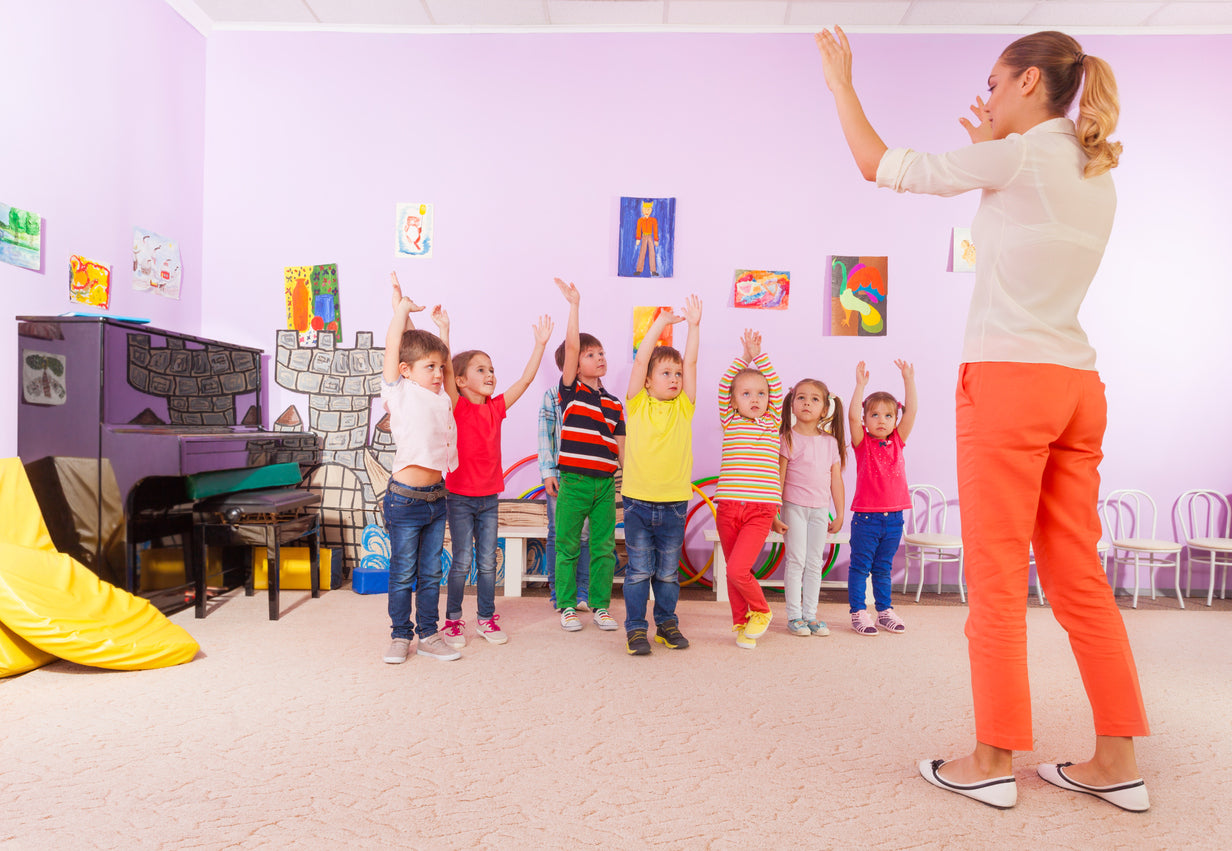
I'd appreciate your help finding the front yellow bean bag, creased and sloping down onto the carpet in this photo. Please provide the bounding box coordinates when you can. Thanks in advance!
[0,543,198,671]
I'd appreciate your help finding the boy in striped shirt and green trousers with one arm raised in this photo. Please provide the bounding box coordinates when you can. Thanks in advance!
[556,278,625,632]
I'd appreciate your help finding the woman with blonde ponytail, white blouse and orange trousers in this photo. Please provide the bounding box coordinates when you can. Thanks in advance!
[817,28,1149,812]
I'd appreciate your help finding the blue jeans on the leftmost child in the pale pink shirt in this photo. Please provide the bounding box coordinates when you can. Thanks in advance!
[384,482,446,638]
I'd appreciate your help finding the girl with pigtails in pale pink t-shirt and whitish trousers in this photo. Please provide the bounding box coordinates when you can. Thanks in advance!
[779,378,846,635]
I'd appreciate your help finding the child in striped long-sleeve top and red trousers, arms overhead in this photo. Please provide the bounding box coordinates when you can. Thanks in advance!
[715,329,782,650]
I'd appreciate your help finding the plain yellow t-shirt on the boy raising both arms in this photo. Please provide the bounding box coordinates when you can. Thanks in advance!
[621,388,694,502]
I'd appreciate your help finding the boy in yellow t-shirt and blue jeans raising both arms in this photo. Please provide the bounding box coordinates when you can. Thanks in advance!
[621,296,701,656]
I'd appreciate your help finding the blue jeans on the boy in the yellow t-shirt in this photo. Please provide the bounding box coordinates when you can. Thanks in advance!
[623,496,689,632]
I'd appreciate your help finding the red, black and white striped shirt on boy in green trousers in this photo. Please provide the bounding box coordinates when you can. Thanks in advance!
[558,378,625,477]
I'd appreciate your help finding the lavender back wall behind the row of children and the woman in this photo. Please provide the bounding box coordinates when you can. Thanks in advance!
[202,33,1232,581]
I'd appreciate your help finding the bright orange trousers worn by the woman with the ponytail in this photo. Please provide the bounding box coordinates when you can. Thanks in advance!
[956,362,1149,750]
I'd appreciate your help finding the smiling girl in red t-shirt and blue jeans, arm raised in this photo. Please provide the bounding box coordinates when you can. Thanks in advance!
[441,317,552,648]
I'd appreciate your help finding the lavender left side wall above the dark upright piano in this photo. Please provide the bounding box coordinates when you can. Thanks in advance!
[0,0,206,456]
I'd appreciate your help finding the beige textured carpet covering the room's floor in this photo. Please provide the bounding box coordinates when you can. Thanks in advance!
[0,590,1232,850]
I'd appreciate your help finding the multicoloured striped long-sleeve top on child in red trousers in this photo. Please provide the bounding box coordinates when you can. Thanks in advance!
[715,352,782,504]
